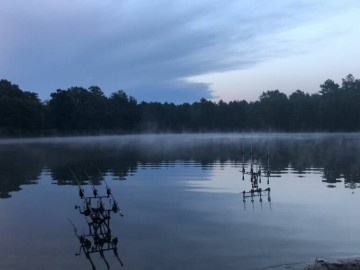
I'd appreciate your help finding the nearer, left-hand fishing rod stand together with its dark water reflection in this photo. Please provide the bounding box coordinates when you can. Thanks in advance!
[70,171,124,270]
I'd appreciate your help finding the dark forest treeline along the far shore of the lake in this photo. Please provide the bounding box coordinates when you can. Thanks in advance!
[0,74,360,137]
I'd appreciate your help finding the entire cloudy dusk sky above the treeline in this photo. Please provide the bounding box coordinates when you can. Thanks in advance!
[0,0,360,103]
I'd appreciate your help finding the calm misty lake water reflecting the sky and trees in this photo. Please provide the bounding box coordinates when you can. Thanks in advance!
[0,134,360,270]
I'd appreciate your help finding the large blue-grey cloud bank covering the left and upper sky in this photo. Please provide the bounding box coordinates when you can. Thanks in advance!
[0,0,358,102]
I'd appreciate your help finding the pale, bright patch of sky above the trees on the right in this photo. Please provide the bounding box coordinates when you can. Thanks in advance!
[189,2,360,101]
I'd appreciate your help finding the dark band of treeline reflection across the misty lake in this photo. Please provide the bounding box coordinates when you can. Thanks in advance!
[0,135,360,198]
